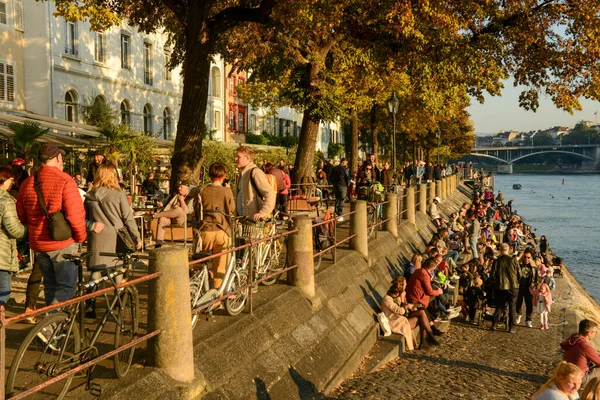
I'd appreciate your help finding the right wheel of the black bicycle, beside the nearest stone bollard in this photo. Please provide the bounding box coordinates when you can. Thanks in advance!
[114,286,138,378]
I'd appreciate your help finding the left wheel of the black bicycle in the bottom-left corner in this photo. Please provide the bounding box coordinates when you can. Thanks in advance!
[6,313,81,399]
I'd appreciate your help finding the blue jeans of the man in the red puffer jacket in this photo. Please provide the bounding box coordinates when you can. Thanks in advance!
[35,243,78,306]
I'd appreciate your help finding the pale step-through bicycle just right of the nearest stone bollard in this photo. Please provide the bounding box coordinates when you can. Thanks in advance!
[190,209,248,329]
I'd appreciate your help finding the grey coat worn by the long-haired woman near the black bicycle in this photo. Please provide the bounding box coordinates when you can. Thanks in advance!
[84,187,142,266]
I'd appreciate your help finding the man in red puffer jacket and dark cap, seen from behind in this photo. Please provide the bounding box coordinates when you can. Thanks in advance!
[17,143,86,305]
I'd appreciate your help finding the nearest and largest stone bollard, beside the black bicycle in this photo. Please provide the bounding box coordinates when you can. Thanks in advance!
[148,247,194,382]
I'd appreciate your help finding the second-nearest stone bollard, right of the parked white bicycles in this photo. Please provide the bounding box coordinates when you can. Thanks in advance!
[287,215,316,298]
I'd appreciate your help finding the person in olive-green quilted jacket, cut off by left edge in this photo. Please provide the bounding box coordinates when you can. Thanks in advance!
[0,167,27,305]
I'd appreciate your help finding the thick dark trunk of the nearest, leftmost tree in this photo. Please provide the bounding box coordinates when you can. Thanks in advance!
[169,1,212,193]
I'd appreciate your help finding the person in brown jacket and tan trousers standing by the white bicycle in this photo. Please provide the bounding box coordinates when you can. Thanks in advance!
[199,162,235,289]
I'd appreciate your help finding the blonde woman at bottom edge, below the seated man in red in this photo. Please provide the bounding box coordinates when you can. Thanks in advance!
[533,361,583,400]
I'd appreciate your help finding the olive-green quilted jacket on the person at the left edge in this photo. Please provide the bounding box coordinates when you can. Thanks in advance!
[0,189,27,272]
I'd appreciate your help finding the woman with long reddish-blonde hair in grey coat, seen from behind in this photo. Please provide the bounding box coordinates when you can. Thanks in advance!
[84,163,142,318]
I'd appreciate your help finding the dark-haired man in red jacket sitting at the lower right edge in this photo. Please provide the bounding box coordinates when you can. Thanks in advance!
[560,319,600,387]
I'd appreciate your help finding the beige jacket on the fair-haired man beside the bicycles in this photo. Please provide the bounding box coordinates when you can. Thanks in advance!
[236,163,277,217]
